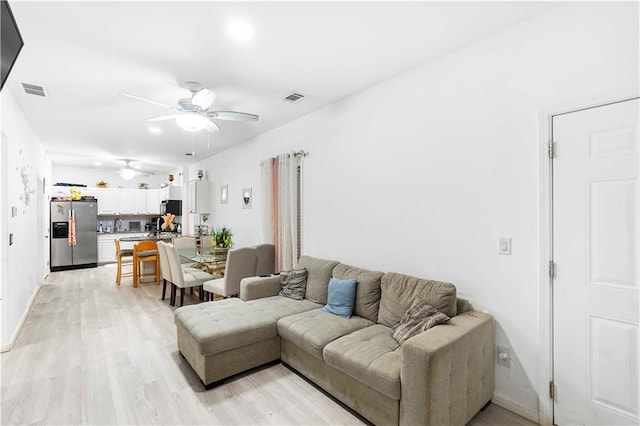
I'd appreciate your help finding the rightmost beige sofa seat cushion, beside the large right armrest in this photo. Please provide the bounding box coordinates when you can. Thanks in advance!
[323,324,402,400]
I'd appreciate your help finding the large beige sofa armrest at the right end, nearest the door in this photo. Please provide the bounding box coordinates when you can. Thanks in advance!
[400,311,495,425]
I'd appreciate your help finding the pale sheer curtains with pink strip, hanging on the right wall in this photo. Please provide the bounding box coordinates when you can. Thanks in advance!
[260,152,300,271]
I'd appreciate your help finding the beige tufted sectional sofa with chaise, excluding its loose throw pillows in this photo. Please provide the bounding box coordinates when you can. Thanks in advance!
[175,256,495,425]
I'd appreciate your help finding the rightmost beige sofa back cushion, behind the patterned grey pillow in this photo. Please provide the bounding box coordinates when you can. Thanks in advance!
[378,272,456,327]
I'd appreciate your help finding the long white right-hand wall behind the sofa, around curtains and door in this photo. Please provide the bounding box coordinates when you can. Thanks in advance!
[190,3,639,418]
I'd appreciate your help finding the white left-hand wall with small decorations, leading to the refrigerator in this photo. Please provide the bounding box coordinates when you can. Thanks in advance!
[0,87,51,348]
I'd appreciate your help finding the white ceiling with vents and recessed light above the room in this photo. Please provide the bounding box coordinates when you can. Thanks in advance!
[4,0,549,175]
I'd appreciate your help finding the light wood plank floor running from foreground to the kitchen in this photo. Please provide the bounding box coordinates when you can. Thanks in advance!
[0,265,533,426]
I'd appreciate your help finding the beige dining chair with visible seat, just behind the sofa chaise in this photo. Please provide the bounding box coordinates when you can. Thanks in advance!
[202,247,257,300]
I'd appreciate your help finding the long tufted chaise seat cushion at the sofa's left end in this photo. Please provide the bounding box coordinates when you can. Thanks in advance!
[174,296,321,355]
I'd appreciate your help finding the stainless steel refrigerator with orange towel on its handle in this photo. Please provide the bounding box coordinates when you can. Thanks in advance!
[50,200,98,271]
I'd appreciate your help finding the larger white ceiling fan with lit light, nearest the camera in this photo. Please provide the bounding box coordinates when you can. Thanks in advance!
[120,81,259,132]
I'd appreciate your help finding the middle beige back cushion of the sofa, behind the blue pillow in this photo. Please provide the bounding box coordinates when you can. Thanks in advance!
[333,263,384,321]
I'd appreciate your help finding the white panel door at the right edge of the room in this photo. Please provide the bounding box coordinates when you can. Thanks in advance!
[553,99,640,425]
